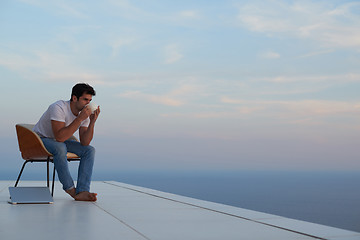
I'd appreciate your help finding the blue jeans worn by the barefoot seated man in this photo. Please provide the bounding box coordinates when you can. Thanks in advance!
[41,138,95,193]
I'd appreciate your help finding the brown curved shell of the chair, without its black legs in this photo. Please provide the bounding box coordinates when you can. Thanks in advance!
[15,124,78,160]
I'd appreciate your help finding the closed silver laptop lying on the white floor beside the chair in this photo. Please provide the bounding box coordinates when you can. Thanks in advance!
[9,187,54,204]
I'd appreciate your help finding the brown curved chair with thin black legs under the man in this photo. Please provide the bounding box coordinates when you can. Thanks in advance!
[15,124,80,196]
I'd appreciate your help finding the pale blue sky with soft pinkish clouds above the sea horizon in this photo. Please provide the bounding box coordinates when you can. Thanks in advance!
[0,0,360,176]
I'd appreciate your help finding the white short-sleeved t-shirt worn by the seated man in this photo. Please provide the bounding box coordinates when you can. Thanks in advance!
[33,100,90,139]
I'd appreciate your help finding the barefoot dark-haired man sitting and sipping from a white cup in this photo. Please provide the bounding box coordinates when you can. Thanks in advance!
[34,83,100,201]
